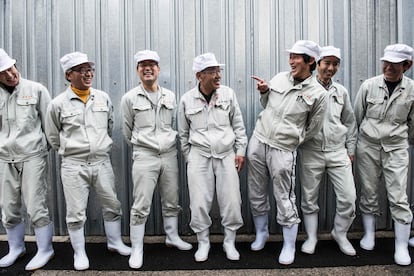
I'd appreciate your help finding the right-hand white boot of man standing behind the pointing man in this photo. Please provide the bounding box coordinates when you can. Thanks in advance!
[331,214,356,256]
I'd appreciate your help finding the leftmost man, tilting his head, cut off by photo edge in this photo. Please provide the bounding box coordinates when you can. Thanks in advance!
[0,49,54,270]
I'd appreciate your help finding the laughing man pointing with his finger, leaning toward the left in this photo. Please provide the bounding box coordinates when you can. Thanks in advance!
[247,40,326,265]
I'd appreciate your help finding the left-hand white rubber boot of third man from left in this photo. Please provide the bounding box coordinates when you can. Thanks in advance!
[128,223,145,269]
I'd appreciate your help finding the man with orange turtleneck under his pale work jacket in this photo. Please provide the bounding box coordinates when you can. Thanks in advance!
[46,52,131,270]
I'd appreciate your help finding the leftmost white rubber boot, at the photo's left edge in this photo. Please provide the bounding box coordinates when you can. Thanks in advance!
[0,222,26,267]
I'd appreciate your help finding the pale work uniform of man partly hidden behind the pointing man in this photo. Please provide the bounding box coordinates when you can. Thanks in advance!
[298,79,357,219]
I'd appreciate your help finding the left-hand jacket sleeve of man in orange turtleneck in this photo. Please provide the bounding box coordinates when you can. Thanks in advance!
[45,102,61,150]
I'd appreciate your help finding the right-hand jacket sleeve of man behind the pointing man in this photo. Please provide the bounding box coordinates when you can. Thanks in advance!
[341,90,358,155]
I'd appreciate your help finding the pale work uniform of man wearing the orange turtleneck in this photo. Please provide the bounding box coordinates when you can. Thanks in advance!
[46,87,122,230]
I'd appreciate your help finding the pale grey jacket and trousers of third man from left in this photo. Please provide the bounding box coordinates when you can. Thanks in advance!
[121,85,181,225]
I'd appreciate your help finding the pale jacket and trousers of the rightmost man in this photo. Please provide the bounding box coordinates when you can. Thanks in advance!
[354,75,414,224]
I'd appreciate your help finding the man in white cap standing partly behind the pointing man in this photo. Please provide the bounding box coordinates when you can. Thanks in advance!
[298,46,357,256]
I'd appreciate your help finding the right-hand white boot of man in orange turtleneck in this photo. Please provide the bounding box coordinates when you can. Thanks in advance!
[104,220,131,256]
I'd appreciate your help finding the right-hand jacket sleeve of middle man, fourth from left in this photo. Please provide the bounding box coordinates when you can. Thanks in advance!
[230,92,247,156]
